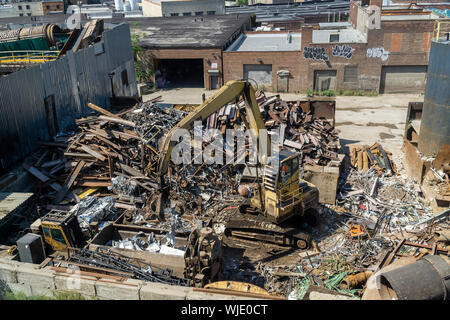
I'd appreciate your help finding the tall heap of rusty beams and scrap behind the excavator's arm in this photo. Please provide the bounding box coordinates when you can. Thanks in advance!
[24,92,340,236]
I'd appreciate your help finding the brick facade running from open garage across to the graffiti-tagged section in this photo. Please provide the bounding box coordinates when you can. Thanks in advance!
[143,16,433,92]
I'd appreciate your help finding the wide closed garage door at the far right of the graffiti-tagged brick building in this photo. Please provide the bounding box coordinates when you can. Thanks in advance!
[380,66,427,93]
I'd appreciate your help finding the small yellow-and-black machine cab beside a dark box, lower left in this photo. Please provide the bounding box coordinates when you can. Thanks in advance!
[36,210,84,251]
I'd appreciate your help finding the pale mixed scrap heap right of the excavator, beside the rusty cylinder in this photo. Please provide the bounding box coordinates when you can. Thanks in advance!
[258,143,450,299]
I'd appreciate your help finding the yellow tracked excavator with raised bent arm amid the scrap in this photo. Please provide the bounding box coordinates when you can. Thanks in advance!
[159,81,319,249]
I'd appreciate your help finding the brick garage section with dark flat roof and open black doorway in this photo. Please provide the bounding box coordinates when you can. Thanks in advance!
[132,15,250,89]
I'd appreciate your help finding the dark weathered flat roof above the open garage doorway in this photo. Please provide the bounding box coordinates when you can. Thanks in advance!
[135,14,250,49]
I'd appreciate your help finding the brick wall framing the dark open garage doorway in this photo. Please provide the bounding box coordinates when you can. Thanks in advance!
[146,49,223,89]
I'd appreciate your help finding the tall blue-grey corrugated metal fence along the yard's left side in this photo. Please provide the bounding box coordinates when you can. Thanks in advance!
[0,24,137,171]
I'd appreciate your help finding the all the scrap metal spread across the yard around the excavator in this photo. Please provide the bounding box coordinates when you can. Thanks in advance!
[10,88,450,299]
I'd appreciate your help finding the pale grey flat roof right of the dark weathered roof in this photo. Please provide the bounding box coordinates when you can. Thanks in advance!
[226,33,302,51]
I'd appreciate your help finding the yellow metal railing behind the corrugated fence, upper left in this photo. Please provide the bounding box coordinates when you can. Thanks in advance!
[0,50,59,64]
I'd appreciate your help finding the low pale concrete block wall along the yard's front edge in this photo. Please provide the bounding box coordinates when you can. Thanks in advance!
[0,259,260,300]
